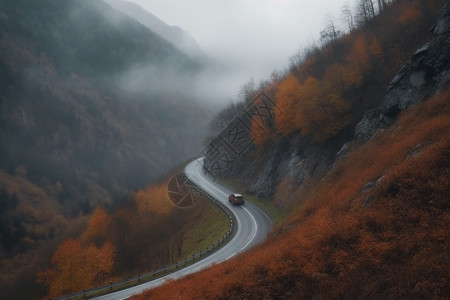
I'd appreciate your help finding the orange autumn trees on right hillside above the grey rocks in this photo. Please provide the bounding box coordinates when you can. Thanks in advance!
[251,1,442,146]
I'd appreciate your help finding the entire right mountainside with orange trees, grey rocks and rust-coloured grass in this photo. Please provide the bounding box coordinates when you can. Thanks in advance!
[133,0,450,299]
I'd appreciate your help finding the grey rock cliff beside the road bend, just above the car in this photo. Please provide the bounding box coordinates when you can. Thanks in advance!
[201,93,341,199]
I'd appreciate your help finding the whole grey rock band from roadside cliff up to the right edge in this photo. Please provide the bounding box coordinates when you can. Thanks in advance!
[203,4,450,200]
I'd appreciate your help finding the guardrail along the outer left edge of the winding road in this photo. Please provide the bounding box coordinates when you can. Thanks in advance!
[55,166,236,300]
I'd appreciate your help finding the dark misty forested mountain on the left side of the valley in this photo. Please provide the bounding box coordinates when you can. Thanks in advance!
[0,0,212,299]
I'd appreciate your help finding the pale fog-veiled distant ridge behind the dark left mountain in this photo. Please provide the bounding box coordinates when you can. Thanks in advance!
[105,0,205,58]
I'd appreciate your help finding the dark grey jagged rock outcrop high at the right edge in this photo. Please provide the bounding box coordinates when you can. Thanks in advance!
[355,3,450,141]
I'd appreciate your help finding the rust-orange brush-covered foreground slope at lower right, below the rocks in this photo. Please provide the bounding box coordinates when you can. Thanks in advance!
[135,92,450,299]
